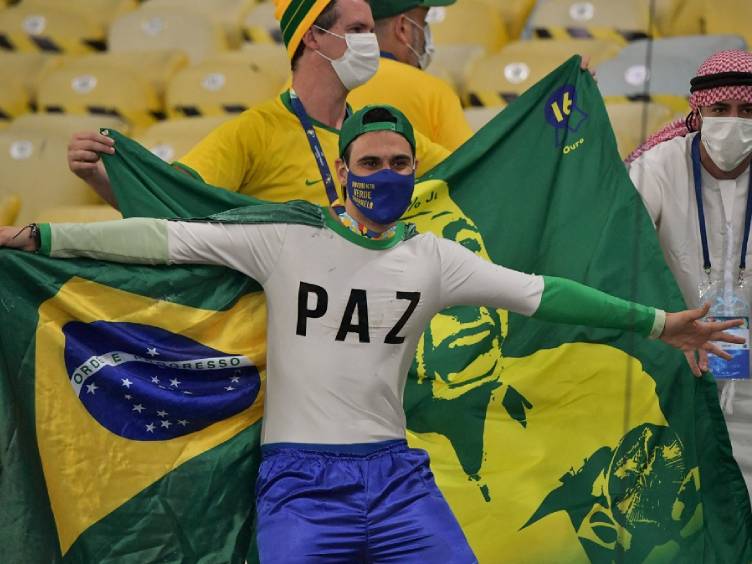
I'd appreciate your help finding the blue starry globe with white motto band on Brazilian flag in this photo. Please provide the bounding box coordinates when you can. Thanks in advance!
[63,321,261,441]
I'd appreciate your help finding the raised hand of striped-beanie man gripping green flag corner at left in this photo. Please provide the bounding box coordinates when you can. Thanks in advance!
[68,131,118,208]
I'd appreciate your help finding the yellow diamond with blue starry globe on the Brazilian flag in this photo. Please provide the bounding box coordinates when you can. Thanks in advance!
[35,277,266,554]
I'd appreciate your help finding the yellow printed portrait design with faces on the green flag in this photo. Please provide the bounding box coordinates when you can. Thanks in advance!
[405,181,702,563]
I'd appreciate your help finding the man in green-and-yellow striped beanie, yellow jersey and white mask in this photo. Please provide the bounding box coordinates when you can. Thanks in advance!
[68,0,449,206]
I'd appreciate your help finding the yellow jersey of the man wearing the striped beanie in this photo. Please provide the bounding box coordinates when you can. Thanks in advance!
[176,91,449,205]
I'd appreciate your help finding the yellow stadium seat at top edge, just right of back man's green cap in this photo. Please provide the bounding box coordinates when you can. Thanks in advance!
[427,0,509,53]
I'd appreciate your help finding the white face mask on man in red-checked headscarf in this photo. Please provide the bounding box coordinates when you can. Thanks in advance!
[700,117,752,172]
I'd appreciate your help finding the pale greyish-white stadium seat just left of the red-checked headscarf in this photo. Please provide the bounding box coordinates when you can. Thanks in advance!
[597,35,744,112]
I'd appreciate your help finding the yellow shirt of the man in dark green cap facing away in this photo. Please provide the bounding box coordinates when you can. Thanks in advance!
[347,55,473,151]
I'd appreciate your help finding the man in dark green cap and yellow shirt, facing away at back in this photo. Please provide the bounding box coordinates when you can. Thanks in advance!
[347,0,473,151]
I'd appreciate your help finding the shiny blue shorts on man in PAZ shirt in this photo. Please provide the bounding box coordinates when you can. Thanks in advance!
[256,441,477,564]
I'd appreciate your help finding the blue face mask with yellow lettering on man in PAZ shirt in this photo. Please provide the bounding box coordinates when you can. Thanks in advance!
[347,168,415,225]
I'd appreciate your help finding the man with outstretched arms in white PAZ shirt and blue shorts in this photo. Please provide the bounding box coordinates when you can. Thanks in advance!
[0,106,740,564]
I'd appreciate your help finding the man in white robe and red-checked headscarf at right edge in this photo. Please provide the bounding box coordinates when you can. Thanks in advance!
[629,51,752,492]
